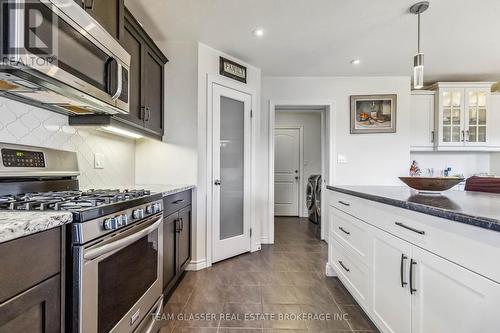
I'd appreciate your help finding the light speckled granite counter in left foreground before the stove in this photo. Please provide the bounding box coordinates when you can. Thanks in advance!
[0,211,73,243]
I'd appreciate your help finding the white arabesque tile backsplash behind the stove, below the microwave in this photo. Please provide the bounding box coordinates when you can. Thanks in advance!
[0,97,135,189]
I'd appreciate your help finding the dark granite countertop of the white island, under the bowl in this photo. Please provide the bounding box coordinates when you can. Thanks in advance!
[327,185,500,232]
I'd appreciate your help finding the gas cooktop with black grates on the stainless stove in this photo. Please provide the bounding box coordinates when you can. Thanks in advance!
[0,189,161,222]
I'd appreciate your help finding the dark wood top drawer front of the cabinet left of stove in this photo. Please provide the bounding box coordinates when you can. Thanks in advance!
[0,228,61,303]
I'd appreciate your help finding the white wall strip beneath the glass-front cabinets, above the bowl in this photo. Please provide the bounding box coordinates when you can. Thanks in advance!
[408,152,490,178]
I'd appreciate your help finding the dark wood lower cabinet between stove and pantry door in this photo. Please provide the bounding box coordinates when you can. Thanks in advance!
[163,190,192,295]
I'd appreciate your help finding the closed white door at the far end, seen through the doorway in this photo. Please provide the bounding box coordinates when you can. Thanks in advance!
[274,128,300,216]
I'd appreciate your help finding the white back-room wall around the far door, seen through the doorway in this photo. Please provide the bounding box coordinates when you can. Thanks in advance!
[274,110,321,216]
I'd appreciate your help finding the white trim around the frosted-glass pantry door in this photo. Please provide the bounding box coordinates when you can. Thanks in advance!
[205,74,260,267]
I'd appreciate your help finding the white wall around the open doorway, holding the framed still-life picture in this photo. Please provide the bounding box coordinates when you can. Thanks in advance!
[259,76,410,239]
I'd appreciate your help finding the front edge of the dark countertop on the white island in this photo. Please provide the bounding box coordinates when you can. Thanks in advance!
[326,185,500,232]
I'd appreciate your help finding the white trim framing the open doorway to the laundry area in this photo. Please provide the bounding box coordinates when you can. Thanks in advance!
[268,100,335,244]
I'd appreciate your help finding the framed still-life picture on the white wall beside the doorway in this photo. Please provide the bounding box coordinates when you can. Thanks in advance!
[351,94,397,134]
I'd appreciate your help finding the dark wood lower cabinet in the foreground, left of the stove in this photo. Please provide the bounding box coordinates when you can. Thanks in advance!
[0,227,64,333]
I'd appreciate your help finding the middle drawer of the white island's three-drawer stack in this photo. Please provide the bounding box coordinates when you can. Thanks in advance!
[330,207,370,264]
